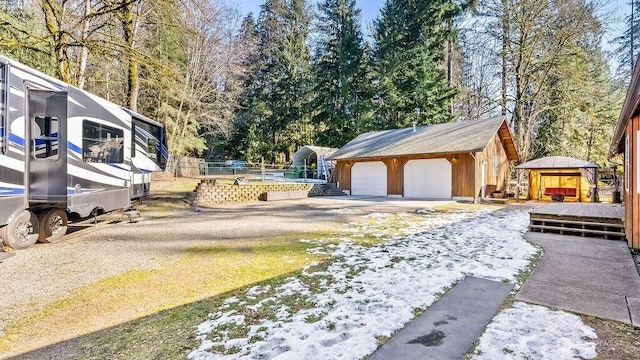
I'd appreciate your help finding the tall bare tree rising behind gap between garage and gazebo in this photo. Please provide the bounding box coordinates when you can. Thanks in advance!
[481,0,600,161]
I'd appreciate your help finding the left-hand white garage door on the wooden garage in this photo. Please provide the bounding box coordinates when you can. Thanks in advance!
[351,161,387,196]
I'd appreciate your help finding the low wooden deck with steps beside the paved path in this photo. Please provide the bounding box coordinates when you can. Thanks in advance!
[529,203,625,240]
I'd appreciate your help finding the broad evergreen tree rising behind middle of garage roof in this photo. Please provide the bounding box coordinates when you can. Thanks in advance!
[374,0,470,128]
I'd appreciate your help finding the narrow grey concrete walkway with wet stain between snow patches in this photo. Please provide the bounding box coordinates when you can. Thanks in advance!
[368,277,513,360]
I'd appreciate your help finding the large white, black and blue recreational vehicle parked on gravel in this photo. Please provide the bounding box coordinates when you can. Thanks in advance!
[0,56,168,249]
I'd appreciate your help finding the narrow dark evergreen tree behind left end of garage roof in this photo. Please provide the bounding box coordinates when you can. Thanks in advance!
[314,0,371,147]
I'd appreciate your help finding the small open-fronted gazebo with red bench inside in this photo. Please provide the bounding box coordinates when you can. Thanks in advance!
[516,156,598,202]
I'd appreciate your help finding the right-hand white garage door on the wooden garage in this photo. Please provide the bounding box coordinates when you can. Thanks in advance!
[404,159,451,199]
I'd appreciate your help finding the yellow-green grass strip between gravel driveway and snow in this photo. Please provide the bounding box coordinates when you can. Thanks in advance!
[0,234,325,359]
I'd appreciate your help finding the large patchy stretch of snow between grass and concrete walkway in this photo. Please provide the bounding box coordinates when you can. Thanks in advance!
[189,207,587,360]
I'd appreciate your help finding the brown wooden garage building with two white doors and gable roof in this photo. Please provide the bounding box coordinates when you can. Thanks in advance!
[330,116,518,200]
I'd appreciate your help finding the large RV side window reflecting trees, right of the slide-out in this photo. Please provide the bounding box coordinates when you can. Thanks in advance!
[82,120,124,164]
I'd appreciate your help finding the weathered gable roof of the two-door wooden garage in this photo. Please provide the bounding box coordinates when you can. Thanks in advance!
[329,116,518,160]
